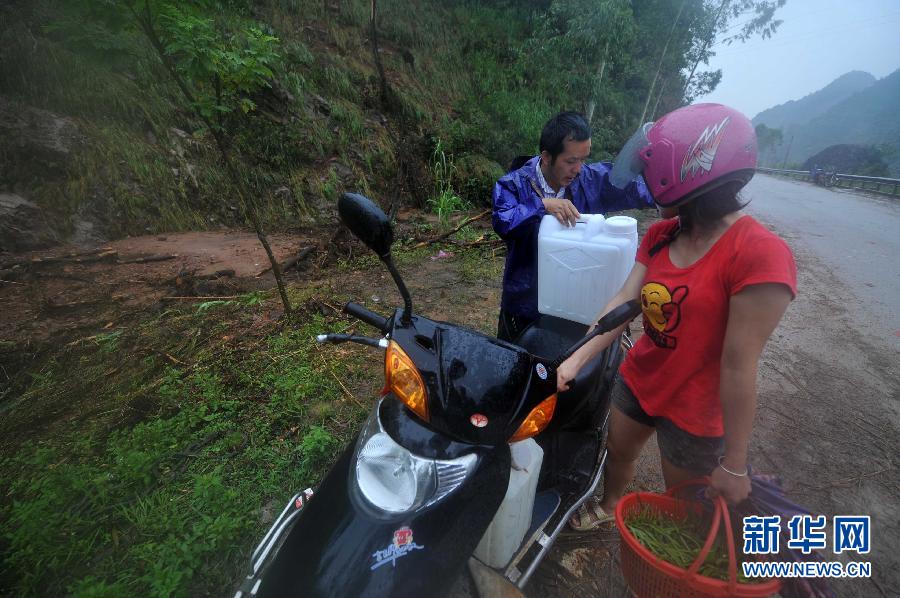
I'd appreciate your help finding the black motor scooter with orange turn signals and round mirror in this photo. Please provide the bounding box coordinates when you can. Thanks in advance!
[236,194,640,597]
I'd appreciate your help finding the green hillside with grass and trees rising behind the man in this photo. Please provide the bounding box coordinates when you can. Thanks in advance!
[0,0,709,245]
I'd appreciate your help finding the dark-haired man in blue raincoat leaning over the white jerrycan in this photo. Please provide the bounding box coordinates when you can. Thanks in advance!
[493,112,654,341]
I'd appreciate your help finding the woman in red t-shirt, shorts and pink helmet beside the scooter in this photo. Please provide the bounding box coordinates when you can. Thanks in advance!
[558,104,797,529]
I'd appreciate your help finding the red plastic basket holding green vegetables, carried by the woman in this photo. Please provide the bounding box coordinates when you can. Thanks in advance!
[616,478,781,598]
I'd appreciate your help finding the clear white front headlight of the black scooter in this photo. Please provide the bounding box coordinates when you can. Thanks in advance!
[356,409,477,513]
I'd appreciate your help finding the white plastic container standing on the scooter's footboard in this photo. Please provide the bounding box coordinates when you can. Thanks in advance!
[474,438,544,568]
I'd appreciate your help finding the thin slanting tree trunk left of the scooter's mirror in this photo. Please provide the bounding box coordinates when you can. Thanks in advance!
[132,0,292,314]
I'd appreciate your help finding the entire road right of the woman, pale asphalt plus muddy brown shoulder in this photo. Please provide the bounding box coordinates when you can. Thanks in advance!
[746,175,900,598]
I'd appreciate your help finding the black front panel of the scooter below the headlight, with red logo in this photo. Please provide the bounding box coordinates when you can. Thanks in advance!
[254,406,510,598]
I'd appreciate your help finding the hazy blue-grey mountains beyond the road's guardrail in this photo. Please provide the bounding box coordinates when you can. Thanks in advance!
[753,70,900,177]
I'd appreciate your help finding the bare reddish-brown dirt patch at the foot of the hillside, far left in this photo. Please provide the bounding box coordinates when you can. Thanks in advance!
[0,230,327,348]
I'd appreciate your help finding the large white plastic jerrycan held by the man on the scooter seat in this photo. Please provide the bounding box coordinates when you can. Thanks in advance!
[538,214,638,324]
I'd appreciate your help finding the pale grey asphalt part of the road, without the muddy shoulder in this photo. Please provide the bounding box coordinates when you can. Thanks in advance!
[744,175,900,348]
